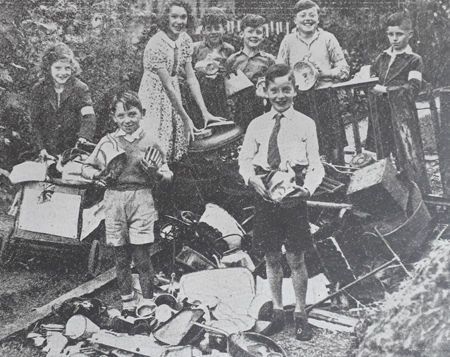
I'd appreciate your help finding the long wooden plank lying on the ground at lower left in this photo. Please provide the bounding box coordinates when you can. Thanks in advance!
[0,268,116,341]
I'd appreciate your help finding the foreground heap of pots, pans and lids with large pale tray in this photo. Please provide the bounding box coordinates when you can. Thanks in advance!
[28,267,292,357]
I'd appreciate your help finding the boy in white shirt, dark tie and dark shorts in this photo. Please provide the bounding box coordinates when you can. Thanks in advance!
[239,64,324,341]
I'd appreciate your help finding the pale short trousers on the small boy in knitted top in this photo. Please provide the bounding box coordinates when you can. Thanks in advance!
[103,188,158,247]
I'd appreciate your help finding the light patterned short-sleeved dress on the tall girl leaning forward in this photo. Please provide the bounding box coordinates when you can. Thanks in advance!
[139,31,192,162]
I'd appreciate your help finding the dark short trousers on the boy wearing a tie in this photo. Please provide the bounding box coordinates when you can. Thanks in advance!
[253,197,314,253]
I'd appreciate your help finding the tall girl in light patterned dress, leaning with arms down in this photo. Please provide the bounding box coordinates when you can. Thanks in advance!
[139,0,223,162]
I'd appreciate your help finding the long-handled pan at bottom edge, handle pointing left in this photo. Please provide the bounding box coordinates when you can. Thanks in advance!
[192,322,287,357]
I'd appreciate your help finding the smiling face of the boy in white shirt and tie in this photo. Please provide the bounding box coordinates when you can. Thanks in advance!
[266,75,297,113]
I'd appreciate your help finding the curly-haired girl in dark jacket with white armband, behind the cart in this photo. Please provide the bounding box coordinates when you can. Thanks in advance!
[30,43,96,159]
